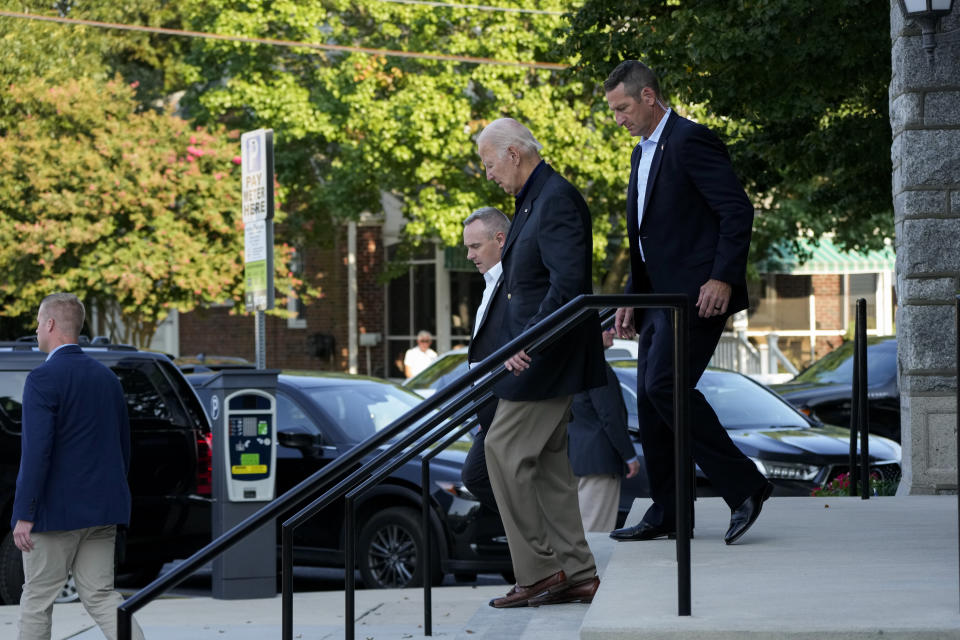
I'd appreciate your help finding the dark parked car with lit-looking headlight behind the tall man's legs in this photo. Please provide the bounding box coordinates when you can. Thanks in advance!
[610,360,901,504]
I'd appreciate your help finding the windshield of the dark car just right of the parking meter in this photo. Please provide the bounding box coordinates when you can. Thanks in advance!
[303,381,421,442]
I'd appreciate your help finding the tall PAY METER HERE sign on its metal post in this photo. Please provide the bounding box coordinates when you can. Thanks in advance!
[240,129,273,369]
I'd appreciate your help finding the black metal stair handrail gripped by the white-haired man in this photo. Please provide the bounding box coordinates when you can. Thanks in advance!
[117,294,692,640]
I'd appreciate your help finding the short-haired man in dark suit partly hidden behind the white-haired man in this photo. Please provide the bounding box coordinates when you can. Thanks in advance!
[460,207,510,513]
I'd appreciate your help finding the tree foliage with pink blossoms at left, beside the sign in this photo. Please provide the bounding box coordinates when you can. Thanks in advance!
[0,78,298,345]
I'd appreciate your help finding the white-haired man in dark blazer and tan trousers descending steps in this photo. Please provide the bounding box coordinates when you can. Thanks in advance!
[477,118,604,608]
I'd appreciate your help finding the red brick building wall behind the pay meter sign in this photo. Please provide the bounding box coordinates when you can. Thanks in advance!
[180,226,384,375]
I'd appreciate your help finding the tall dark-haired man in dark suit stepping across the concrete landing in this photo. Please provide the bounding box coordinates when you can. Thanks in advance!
[603,60,773,544]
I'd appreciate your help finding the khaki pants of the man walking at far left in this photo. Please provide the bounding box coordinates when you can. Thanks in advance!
[19,526,143,640]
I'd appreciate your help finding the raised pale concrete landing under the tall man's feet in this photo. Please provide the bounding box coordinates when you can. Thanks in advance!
[580,496,960,640]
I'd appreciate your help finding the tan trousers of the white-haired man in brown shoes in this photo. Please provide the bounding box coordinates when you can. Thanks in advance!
[484,396,597,586]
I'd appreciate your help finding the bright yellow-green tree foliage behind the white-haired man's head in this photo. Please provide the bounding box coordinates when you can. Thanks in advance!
[179,0,630,284]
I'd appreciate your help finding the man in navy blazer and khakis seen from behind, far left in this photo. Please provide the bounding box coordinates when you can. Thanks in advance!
[10,293,143,640]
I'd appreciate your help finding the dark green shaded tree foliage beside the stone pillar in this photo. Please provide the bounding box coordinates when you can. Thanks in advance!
[564,0,893,262]
